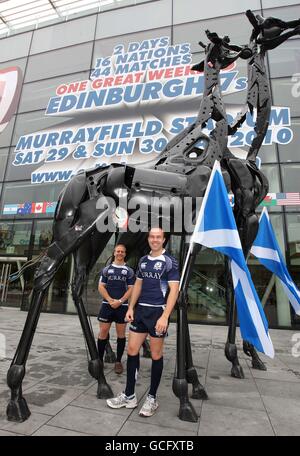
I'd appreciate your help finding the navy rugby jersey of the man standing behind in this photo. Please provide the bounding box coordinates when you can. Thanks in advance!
[99,263,135,305]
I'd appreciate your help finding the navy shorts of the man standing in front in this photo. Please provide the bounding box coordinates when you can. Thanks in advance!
[129,305,168,338]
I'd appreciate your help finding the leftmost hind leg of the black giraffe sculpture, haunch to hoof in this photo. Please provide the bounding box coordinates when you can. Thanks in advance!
[7,176,115,422]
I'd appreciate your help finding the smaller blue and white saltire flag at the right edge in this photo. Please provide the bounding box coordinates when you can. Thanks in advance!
[250,207,300,315]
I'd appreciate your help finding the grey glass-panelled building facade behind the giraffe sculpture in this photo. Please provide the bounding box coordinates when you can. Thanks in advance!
[0,0,300,327]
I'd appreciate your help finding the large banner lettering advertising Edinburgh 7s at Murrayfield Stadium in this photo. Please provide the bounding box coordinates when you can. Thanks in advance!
[9,37,293,184]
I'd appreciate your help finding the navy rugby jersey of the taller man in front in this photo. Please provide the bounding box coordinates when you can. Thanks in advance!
[136,251,180,306]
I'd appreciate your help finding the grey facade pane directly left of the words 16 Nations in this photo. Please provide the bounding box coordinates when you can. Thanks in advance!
[25,43,93,82]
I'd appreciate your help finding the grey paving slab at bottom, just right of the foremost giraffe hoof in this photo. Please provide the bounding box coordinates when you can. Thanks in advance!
[198,402,274,436]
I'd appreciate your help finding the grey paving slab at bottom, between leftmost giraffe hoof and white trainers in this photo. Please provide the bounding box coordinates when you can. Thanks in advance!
[48,406,126,435]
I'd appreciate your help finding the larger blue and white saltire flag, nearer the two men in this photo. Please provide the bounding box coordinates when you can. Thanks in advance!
[190,161,274,358]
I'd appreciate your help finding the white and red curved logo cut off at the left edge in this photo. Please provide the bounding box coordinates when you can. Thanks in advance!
[0,67,22,133]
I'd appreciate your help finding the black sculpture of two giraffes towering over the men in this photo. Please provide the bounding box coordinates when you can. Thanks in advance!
[7,11,300,421]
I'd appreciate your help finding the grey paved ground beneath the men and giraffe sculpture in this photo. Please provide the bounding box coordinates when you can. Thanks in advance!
[0,308,300,436]
